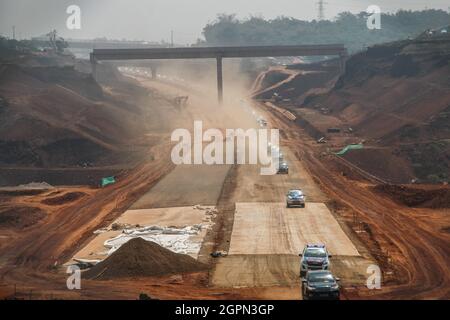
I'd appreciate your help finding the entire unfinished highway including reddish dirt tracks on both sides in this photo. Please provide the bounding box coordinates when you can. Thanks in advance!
[1,63,448,299]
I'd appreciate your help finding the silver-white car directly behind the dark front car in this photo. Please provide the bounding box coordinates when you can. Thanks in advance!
[299,244,331,277]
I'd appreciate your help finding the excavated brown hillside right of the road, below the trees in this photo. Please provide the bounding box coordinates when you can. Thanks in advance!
[263,38,450,183]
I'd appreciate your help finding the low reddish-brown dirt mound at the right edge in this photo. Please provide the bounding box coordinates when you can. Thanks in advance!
[374,185,450,209]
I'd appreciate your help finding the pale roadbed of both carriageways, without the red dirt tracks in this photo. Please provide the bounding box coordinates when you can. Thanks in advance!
[66,74,373,299]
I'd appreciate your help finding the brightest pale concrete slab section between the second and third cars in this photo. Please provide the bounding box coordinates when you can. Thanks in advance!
[229,202,359,256]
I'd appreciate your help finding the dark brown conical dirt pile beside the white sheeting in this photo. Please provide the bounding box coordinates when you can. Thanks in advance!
[83,238,207,280]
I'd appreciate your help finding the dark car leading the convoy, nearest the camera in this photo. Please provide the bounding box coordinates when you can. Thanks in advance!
[302,270,340,300]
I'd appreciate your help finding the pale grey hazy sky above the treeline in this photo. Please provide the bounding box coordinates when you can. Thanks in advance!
[0,0,450,44]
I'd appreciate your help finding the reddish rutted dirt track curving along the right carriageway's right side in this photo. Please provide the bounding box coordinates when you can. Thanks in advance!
[264,101,450,299]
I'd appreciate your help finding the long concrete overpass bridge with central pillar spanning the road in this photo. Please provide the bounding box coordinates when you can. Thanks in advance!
[91,44,347,103]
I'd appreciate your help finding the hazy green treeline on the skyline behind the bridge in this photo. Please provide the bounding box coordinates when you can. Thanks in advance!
[199,10,450,52]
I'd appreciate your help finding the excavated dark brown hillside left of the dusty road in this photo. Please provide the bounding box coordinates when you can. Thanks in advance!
[0,52,160,185]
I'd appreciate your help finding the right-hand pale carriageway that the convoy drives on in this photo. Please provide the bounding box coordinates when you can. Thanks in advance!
[211,146,373,299]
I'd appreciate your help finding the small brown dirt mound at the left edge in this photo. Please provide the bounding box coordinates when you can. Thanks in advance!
[0,206,47,230]
